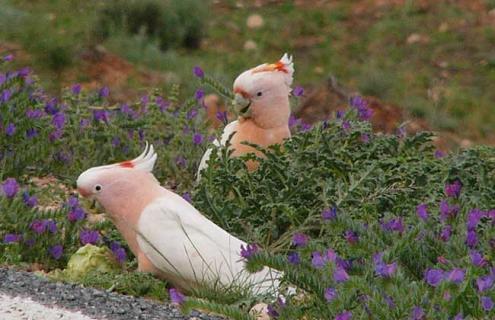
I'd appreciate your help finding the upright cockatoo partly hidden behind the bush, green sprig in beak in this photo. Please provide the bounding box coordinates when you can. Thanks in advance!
[197,53,294,180]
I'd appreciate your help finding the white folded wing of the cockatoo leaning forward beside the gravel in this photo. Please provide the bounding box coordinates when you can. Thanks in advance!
[137,191,280,293]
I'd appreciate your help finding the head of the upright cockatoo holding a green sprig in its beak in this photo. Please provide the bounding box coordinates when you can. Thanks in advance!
[234,53,294,128]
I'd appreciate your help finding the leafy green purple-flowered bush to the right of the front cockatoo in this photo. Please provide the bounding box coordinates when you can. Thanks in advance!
[195,99,495,319]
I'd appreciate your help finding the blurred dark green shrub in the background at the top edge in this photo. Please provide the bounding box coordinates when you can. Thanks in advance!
[96,0,207,50]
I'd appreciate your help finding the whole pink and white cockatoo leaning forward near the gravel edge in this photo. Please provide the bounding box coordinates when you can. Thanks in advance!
[77,145,281,293]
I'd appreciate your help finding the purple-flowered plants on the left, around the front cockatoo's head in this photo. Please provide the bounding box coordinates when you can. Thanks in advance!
[0,55,208,269]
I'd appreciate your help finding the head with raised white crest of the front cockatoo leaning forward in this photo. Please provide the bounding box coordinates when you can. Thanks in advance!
[77,143,159,209]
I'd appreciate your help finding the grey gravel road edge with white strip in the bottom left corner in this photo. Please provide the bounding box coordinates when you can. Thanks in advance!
[0,268,225,320]
